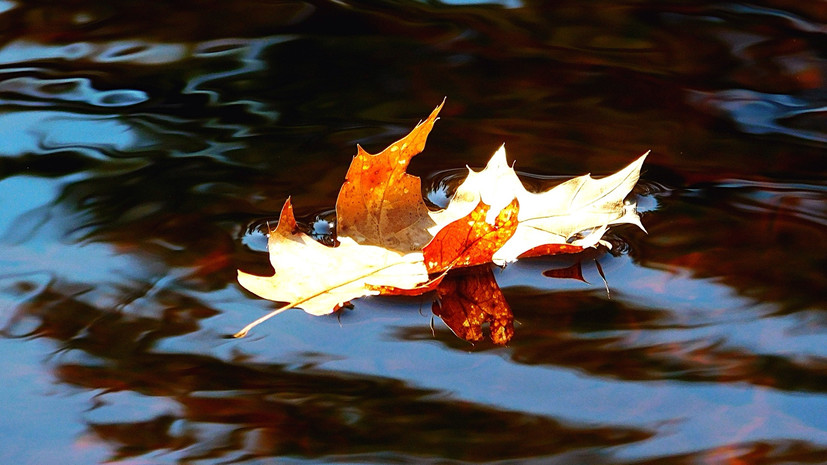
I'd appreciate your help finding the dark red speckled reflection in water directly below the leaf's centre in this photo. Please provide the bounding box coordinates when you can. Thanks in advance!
[432,265,514,344]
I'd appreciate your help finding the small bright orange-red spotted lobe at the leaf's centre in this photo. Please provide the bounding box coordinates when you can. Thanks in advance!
[422,199,520,273]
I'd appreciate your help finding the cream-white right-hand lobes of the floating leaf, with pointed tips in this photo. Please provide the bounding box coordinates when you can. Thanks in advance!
[431,146,648,265]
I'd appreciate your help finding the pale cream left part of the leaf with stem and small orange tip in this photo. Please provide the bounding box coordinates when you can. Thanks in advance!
[236,198,428,337]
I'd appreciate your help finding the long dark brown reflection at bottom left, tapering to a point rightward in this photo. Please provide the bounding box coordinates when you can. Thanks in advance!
[55,316,651,461]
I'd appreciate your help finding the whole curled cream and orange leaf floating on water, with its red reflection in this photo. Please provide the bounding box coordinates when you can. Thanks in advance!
[235,102,646,344]
